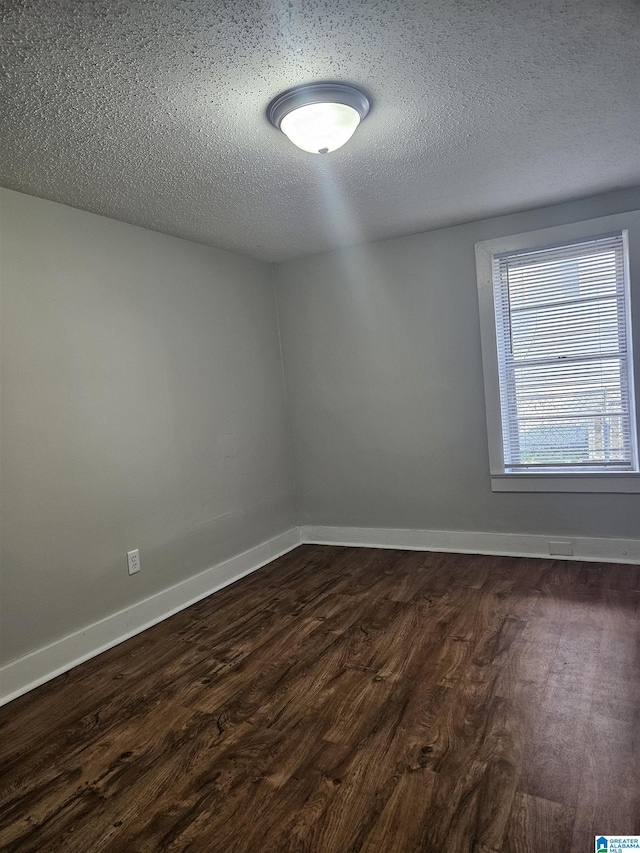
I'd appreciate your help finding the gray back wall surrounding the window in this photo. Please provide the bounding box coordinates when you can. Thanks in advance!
[277,190,640,537]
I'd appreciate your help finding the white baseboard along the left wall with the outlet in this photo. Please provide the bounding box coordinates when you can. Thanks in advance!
[0,527,300,705]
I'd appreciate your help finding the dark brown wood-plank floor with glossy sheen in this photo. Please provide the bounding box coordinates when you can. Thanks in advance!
[0,546,640,853]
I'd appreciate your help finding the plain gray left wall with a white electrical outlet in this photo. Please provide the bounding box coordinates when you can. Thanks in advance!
[0,190,296,662]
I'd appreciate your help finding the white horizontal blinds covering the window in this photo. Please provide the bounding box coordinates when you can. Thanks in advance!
[494,234,634,472]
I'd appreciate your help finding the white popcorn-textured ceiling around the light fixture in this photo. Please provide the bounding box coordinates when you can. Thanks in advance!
[0,0,640,260]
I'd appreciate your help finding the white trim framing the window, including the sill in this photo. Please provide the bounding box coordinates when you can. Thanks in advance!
[476,210,640,493]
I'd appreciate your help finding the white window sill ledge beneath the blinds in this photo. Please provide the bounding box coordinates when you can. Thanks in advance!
[491,472,640,494]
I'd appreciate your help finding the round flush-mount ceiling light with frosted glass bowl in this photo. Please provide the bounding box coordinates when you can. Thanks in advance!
[267,83,369,154]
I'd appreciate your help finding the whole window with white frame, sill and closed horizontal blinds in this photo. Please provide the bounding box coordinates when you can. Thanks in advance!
[476,214,640,491]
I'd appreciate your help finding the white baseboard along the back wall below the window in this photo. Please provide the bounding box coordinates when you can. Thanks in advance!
[301,525,640,565]
